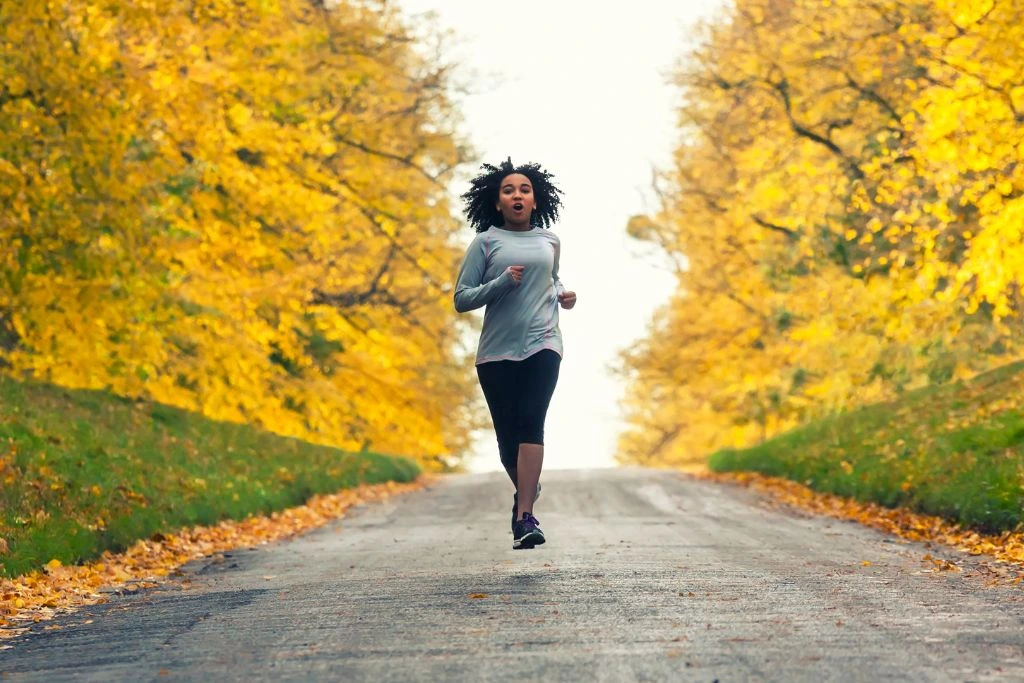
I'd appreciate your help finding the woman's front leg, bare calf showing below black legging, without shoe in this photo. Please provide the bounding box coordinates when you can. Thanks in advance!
[516,349,561,518]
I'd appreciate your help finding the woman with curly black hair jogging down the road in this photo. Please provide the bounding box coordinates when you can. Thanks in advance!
[455,159,577,549]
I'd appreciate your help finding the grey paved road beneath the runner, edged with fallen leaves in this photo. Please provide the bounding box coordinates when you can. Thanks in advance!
[0,470,1024,682]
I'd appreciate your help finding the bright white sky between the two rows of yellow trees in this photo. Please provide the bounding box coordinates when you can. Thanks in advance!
[397,0,720,471]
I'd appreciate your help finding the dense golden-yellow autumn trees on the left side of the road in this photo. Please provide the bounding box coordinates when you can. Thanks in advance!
[0,0,479,467]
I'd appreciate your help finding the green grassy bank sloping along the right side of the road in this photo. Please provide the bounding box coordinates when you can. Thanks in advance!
[709,362,1024,531]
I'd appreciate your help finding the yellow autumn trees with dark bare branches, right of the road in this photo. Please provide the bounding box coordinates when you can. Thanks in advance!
[620,0,1024,464]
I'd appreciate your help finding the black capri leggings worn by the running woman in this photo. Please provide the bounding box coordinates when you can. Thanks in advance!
[476,349,562,470]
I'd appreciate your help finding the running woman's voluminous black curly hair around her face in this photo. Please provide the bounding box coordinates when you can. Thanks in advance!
[462,157,562,232]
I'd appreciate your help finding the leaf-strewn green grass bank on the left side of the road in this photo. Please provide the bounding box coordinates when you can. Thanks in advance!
[0,377,420,577]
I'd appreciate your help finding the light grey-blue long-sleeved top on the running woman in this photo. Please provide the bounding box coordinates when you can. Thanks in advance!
[455,226,565,365]
